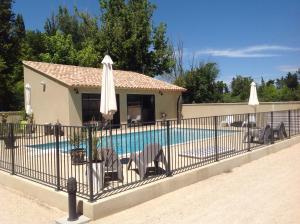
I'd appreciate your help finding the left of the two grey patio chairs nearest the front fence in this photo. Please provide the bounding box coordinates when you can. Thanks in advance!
[98,148,123,181]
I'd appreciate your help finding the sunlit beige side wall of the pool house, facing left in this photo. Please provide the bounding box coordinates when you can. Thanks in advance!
[24,66,70,124]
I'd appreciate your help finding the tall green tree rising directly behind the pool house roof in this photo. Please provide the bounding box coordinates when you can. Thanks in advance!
[99,0,174,76]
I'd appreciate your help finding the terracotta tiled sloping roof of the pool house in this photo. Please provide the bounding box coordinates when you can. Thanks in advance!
[23,61,185,92]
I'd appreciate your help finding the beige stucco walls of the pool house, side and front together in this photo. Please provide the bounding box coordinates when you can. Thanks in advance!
[24,66,181,125]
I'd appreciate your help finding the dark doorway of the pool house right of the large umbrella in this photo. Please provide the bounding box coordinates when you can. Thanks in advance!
[127,94,155,123]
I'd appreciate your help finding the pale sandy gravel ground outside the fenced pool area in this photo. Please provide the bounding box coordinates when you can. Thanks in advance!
[0,144,300,224]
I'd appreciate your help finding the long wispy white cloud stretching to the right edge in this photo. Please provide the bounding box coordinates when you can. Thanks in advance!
[195,45,300,58]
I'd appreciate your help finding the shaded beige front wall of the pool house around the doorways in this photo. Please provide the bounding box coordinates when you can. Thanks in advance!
[69,88,181,125]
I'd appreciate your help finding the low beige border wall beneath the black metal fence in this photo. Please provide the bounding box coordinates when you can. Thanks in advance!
[0,136,300,220]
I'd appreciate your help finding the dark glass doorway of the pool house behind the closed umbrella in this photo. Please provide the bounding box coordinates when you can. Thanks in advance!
[81,93,120,127]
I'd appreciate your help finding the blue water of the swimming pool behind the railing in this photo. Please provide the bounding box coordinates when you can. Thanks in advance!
[29,128,234,154]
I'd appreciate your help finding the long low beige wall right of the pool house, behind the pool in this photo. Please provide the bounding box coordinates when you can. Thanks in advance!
[182,101,300,118]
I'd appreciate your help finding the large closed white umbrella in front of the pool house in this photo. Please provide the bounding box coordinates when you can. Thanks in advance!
[100,55,117,121]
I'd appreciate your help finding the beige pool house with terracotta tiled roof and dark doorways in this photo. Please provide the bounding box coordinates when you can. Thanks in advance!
[23,61,185,125]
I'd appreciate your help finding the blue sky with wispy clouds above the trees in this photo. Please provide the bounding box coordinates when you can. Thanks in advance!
[14,0,300,82]
